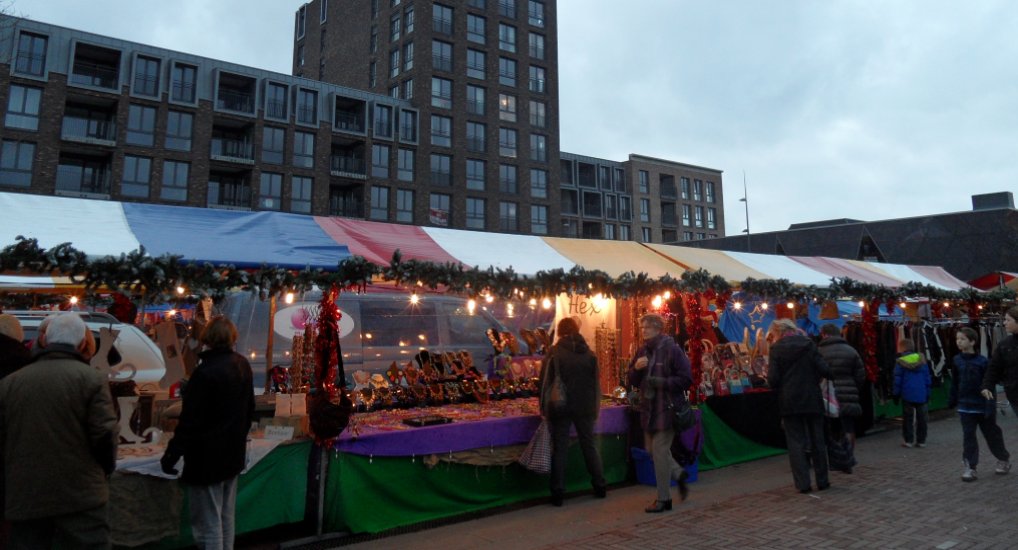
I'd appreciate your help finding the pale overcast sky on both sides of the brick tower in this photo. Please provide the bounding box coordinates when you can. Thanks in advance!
[11,0,1018,234]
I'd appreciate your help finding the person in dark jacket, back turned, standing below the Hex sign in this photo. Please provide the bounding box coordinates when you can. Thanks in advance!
[540,317,608,506]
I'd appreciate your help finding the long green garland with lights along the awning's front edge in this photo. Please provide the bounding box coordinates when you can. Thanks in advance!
[0,236,1016,305]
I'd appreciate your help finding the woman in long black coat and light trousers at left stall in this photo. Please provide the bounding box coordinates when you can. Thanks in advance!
[162,317,255,549]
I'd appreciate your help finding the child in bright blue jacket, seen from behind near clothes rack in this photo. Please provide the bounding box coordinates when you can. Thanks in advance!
[894,338,932,447]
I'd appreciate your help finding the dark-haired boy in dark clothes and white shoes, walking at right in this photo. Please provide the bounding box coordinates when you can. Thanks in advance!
[948,327,1011,482]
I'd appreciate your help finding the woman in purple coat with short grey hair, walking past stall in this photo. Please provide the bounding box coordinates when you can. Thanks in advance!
[629,314,692,513]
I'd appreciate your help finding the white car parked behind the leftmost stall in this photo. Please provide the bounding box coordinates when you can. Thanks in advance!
[4,311,165,391]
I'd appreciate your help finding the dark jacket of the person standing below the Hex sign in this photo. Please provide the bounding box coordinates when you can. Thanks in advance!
[540,334,601,418]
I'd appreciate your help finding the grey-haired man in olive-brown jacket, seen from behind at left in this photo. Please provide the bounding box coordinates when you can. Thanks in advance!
[0,314,117,548]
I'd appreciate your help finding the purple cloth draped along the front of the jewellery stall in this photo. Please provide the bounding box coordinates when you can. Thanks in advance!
[337,405,629,456]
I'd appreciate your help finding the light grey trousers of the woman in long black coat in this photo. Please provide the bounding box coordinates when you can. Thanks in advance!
[187,478,237,550]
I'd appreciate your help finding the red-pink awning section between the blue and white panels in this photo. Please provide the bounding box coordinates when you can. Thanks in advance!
[315,216,459,266]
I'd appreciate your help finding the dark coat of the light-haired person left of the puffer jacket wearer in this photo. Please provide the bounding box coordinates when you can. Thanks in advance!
[768,334,831,417]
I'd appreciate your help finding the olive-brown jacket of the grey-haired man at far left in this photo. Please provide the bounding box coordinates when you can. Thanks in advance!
[0,344,118,521]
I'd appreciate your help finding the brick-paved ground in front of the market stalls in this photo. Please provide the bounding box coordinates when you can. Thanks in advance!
[307,411,1018,550]
